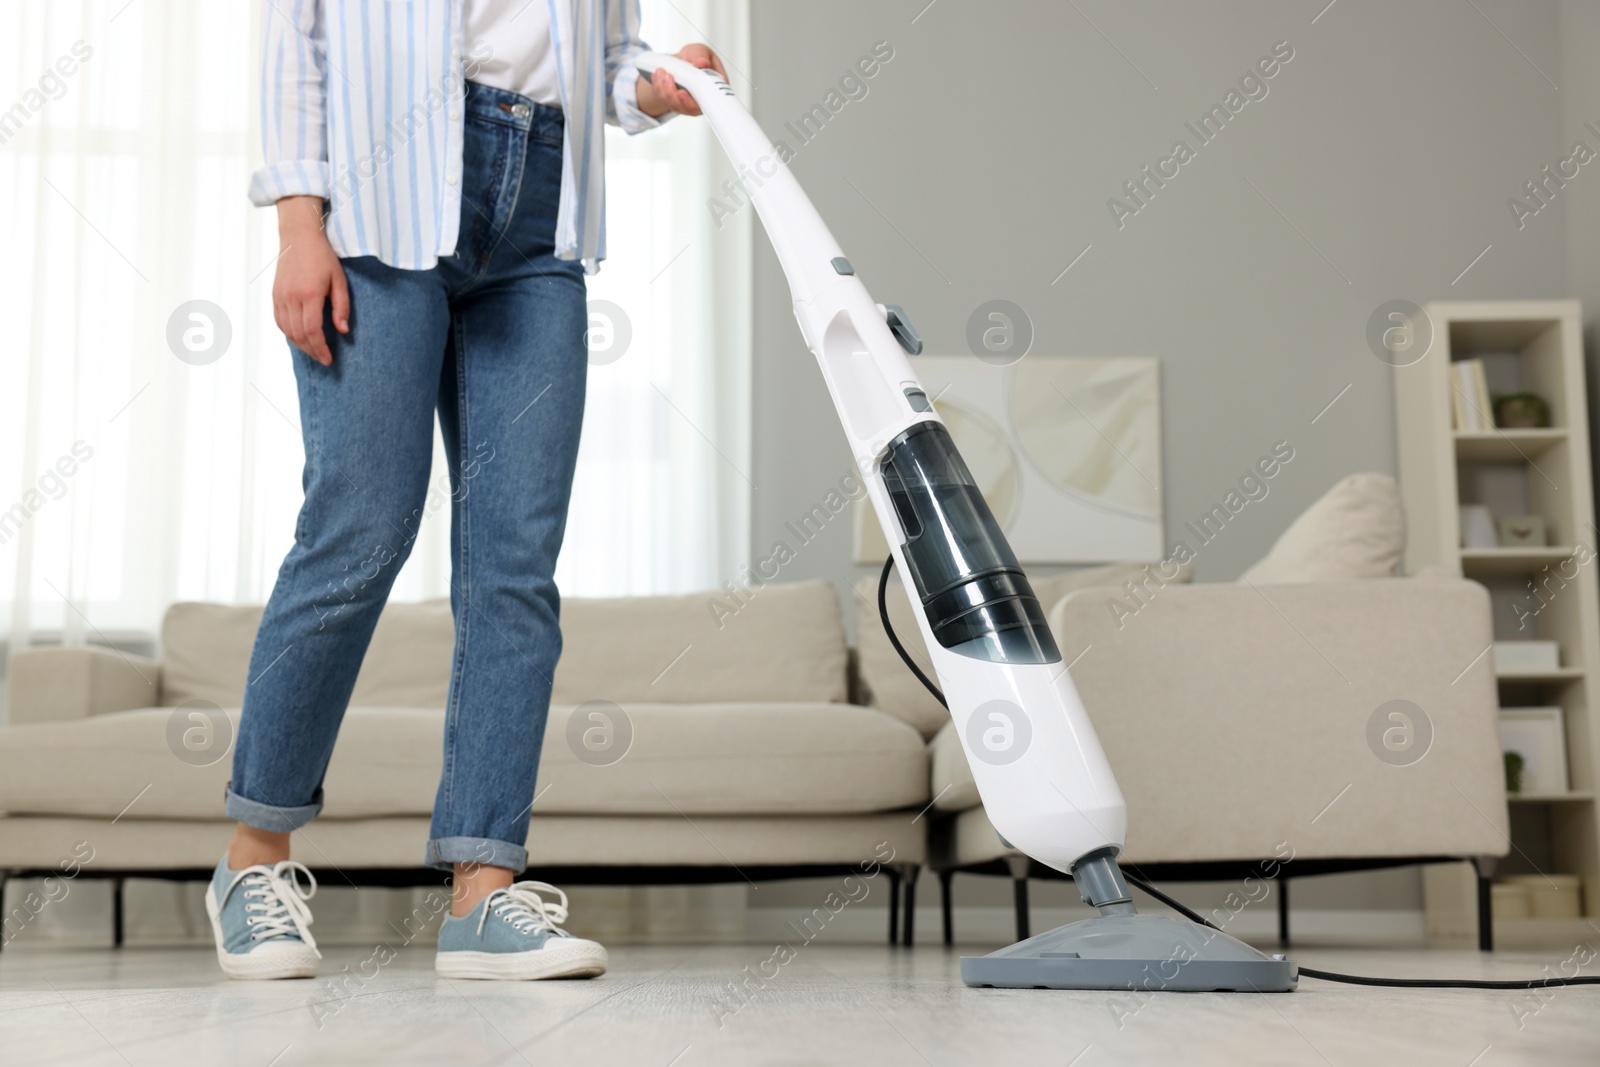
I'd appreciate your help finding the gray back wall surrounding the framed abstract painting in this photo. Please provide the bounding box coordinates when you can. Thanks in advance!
[750,0,1574,909]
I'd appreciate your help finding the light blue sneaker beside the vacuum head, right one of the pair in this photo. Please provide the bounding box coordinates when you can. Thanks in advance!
[434,881,606,979]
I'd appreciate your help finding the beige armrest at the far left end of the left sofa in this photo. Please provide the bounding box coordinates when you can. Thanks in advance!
[8,645,162,726]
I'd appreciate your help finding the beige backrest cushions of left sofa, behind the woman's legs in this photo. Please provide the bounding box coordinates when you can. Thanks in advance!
[162,581,848,709]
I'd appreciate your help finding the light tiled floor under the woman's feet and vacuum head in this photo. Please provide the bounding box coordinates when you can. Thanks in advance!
[0,944,1600,1067]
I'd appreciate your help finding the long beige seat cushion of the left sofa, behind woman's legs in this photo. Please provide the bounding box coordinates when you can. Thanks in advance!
[0,702,928,819]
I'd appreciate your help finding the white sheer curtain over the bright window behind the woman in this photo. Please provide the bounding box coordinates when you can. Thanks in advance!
[0,0,750,710]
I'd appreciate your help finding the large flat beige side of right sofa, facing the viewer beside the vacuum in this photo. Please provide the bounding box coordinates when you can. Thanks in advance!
[1050,579,1509,862]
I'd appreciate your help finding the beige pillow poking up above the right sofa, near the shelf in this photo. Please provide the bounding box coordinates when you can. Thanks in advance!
[1240,474,1405,585]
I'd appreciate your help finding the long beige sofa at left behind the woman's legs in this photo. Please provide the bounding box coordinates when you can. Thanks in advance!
[0,582,930,928]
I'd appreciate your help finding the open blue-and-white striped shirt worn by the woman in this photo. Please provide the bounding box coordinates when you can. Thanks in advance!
[250,0,659,274]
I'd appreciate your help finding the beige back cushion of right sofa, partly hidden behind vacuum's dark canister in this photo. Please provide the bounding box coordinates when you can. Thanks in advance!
[856,563,1194,737]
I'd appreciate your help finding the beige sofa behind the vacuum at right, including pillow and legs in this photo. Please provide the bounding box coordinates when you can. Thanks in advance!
[858,475,1510,947]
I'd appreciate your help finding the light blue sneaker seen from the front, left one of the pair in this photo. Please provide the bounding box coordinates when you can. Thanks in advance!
[205,856,322,979]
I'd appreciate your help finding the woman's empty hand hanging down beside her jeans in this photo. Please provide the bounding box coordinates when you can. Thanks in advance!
[272,197,350,366]
